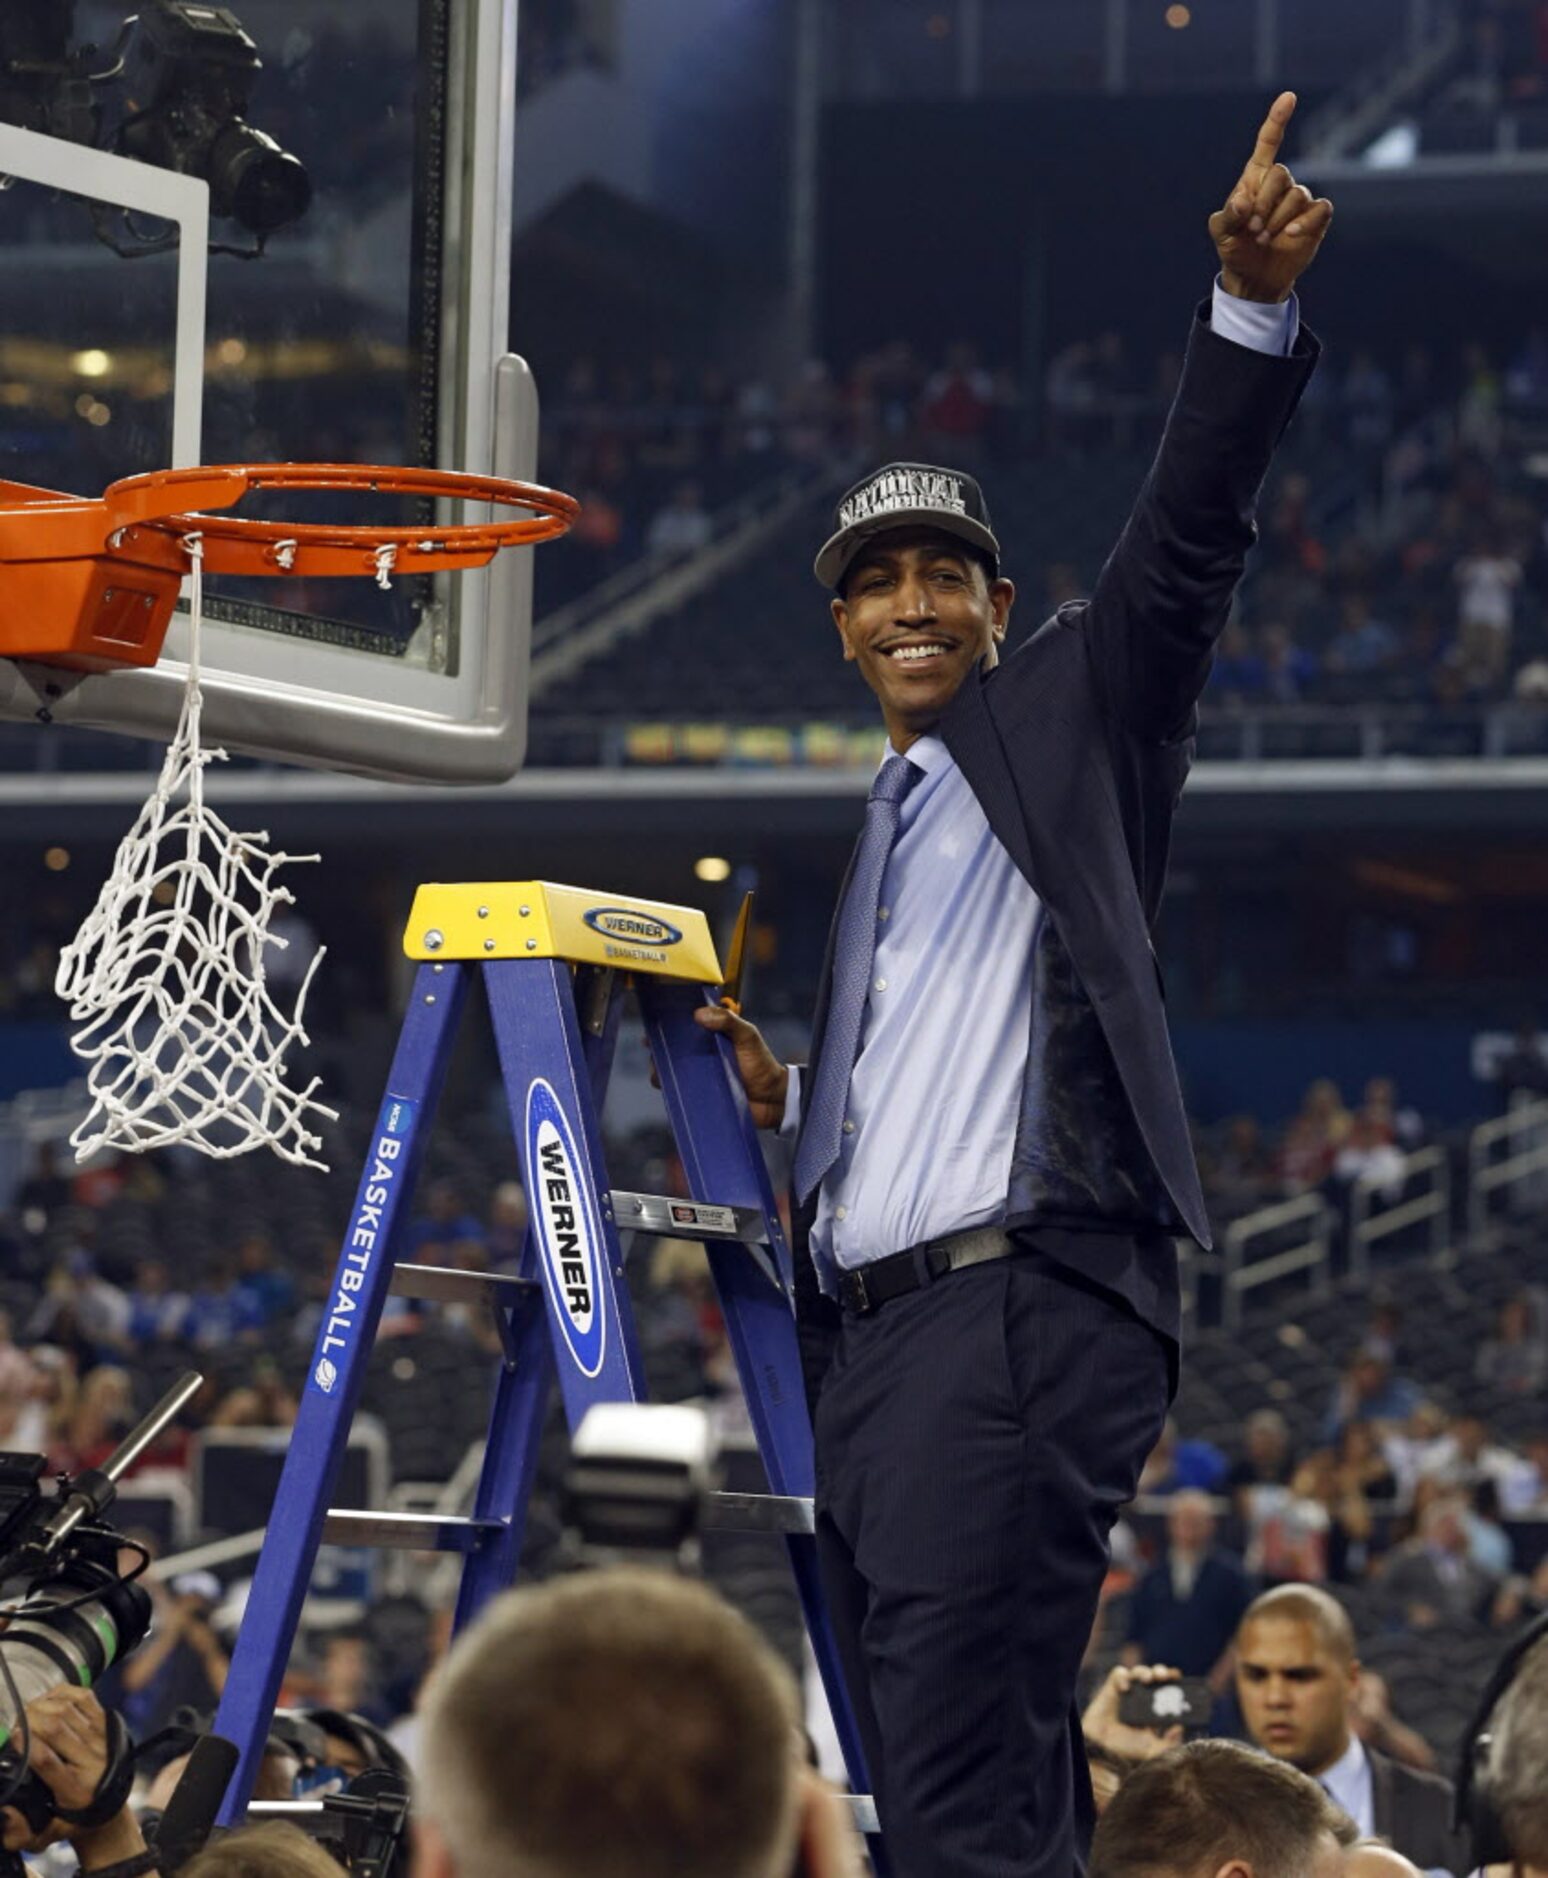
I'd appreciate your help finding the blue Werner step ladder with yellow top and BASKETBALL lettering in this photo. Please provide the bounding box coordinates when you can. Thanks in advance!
[214,881,887,1847]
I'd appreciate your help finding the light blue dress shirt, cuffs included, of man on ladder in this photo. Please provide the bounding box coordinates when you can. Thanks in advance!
[780,285,1300,1292]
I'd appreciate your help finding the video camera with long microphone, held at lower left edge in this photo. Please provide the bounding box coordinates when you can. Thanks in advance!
[0,1371,203,1831]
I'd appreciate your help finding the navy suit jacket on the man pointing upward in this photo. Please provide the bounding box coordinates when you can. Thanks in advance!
[793,306,1319,1390]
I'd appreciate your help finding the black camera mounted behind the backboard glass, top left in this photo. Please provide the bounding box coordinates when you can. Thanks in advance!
[0,0,312,242]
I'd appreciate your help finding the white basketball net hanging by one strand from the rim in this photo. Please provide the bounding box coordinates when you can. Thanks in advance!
[54,535,338,1168]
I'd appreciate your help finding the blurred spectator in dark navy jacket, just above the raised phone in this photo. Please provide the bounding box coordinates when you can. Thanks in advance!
[1123,1487,1251,1683]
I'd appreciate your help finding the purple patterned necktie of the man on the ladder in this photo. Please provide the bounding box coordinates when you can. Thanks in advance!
[795,757,924,1200]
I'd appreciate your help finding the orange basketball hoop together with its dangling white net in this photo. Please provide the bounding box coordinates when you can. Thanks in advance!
[0,464,581,1168]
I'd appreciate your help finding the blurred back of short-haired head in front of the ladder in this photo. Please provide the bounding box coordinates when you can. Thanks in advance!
[417,1570,859,1878]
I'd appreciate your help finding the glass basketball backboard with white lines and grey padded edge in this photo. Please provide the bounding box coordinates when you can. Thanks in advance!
[0,0,537,781]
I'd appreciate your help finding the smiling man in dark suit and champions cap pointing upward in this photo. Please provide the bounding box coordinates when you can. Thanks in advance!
[699,92,1332,1878]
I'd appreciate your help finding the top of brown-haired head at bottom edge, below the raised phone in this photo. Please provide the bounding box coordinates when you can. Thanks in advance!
[1086,1741,1343,1878]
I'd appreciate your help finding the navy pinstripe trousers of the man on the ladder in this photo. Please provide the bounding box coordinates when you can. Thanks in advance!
[815,1251,1170,1878]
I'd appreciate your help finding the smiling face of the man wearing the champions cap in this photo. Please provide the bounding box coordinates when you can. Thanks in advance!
[832,528,1016,753]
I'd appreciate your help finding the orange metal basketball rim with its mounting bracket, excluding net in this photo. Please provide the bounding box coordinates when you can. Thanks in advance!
[0,464,581,672]
